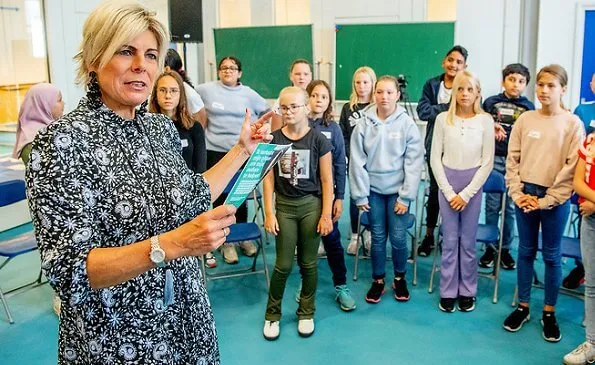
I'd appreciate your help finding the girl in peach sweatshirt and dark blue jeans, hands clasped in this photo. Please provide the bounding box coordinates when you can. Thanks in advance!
[503,65,585,342]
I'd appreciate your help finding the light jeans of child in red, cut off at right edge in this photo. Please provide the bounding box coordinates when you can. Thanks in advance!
[581,215,595,344]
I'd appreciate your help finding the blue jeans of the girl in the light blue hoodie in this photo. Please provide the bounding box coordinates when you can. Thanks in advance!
[368,191,408,280]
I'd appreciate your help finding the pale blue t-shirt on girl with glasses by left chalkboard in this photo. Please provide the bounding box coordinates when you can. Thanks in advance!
[196,81,270,152]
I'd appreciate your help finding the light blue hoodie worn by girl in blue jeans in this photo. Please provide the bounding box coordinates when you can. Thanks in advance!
[349,104,424,205]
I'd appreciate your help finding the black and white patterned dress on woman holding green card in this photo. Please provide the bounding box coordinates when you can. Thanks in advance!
[27,98,219,364]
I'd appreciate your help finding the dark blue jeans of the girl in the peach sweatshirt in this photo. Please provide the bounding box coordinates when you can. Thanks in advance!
[515,183,570,306]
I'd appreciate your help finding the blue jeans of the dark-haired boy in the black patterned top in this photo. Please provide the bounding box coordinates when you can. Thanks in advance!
[485,156,515,249]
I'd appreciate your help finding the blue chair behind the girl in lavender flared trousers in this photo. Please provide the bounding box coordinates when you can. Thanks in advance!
[428,170,506,304]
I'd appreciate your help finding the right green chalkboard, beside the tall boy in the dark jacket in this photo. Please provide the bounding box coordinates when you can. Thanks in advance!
[335,22,454,102]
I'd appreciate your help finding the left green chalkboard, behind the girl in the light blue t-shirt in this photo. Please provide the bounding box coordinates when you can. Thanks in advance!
[214,25,313,99]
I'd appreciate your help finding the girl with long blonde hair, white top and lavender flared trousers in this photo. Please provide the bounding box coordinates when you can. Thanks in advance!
[430,70,494,313]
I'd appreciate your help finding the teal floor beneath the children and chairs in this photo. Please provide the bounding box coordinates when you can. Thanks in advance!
[0,200,585,365]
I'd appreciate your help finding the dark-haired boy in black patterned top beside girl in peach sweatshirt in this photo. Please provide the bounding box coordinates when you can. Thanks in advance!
[479,63,535,270]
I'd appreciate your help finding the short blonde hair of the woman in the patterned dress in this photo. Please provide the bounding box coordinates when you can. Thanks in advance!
[74,1,169,85]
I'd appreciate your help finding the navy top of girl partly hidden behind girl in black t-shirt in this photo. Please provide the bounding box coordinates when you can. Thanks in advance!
[308,118,347,200]
